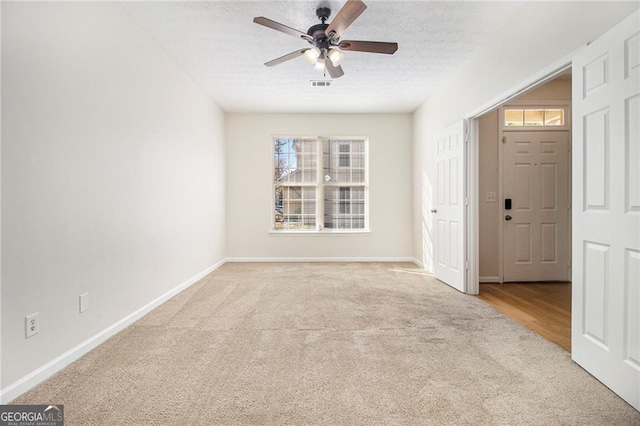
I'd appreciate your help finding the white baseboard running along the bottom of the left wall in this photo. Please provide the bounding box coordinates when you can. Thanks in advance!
[0,259,226,404]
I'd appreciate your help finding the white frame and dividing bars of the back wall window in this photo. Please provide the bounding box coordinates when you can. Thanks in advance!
[269,134,371,235]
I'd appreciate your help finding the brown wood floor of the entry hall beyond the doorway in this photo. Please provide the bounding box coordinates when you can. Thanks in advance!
[478,283,571,352]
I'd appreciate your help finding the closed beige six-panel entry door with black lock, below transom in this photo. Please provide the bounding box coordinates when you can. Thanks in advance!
[502,131,570,281]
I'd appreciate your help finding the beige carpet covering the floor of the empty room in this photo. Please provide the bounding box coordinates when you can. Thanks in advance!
[14,263,640,425]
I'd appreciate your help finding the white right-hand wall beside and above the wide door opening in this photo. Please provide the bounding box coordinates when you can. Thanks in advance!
[413,2,639,269]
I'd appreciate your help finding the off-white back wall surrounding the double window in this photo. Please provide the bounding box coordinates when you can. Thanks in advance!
[226,114,412,260]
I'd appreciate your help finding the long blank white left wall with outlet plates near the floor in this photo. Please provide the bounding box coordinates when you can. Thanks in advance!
[1,2,226,395]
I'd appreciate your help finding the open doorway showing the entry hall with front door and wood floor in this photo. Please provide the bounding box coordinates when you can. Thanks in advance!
[477,74,571,351]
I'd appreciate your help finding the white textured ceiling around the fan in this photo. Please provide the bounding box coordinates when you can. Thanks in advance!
[121,0,524,113]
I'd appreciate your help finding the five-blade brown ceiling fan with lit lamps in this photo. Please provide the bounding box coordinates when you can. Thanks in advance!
[253,0,398,78]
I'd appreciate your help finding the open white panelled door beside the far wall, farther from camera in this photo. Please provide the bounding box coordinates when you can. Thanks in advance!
[432,121,466,292]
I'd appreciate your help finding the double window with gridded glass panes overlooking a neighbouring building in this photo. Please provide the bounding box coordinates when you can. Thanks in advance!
[273,137,368,232]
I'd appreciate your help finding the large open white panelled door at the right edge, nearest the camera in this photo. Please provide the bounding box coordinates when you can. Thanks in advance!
[571,12,640,410]
